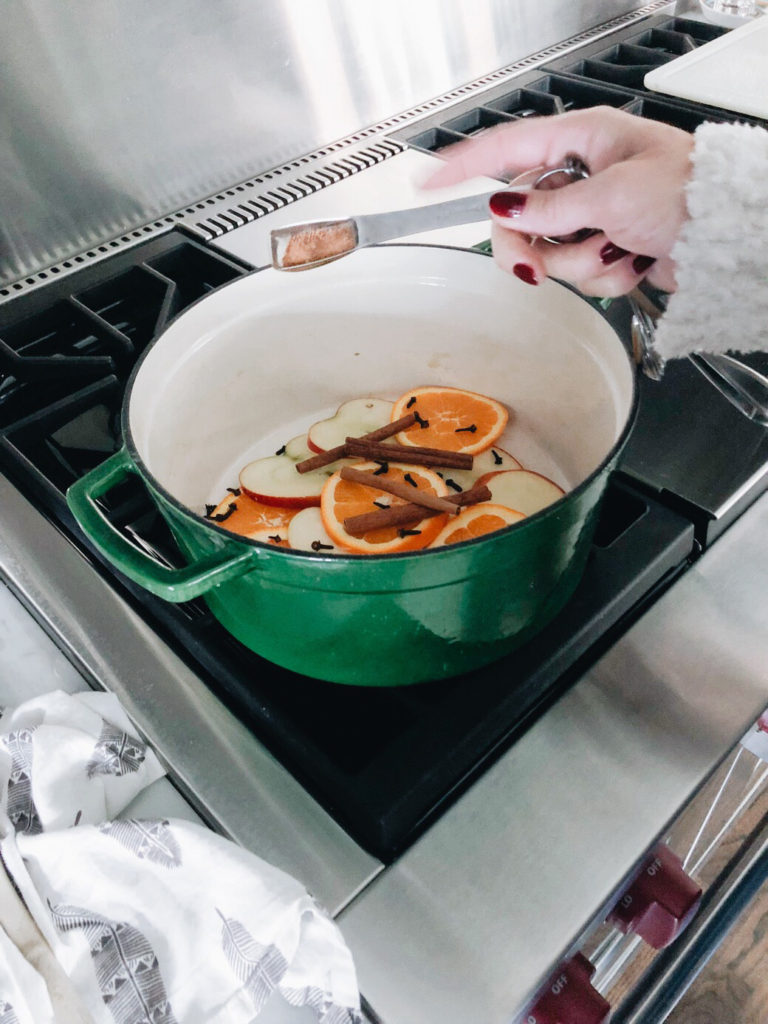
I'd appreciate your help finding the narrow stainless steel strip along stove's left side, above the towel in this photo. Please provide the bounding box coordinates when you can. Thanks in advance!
[0,476,381,912]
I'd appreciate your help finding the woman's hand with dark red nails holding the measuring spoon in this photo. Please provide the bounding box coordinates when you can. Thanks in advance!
[425,106,693,297]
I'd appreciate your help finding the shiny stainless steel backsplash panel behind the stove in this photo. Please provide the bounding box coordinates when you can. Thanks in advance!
[0,0,658,284]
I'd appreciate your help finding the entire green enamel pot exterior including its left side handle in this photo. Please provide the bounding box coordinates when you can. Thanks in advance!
[68,243,634,686]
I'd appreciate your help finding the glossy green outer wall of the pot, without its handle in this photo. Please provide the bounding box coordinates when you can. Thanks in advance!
[157,474,618,686]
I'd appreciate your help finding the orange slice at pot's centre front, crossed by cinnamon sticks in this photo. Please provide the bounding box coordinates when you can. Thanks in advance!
[321,462,449,555]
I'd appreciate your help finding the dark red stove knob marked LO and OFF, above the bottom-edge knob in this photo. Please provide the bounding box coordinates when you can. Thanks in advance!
[608,843,701,949]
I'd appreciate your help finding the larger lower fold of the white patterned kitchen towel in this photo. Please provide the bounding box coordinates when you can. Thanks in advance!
[0,820,361,1024]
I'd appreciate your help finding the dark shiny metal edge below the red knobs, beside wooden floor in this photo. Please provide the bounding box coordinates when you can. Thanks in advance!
[611,817,768,1024]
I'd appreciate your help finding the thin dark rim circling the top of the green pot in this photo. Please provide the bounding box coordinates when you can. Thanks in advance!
[121,242,639,565]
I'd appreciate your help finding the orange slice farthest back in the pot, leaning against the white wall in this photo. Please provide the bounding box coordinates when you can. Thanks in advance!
[392,387,509,455]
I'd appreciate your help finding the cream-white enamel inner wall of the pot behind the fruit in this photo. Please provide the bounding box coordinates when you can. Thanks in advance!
[127,245,634,516]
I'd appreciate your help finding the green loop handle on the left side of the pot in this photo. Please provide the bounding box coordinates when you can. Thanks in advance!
[67,449,254,603]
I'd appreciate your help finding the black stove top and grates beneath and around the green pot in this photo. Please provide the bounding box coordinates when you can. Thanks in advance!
[0,8,768,861]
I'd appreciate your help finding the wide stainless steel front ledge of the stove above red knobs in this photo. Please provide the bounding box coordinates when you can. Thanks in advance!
[341,496,768,1024]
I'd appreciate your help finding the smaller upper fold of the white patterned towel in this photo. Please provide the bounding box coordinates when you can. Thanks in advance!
[0,690,165,835]
